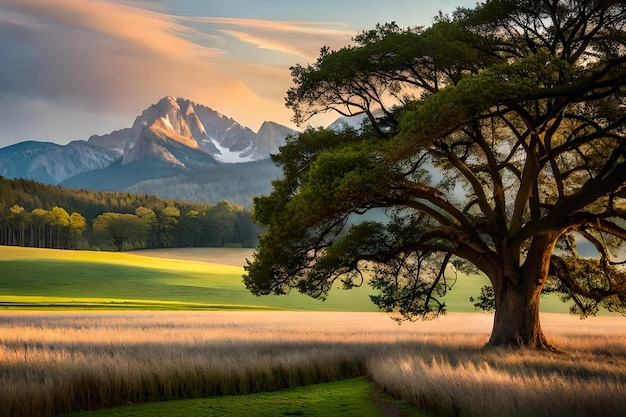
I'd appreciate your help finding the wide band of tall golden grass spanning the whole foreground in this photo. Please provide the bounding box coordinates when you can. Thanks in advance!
[0,312,626,416]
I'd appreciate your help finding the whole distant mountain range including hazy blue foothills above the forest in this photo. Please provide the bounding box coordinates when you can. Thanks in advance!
[0,97,297,206]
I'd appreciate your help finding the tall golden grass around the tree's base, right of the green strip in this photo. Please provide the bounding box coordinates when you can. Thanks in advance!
[367,328,626,417]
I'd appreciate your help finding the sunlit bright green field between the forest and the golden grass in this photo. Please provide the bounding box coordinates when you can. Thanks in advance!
[0,246,566,312]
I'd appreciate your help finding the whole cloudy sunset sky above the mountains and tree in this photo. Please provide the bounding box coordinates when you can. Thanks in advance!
[0,0,476,147]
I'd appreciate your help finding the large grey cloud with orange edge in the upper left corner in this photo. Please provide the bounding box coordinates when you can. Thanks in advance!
[0,0,220,110]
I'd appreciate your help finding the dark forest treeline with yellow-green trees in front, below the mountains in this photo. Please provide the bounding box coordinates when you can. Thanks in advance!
[0,176,261,250]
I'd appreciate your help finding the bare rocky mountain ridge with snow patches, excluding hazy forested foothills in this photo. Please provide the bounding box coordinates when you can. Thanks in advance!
[0,96,296,186]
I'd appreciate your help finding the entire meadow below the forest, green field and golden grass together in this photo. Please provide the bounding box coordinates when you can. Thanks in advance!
[0,247,626,417]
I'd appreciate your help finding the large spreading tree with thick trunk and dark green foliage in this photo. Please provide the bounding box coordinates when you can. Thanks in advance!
[244,0,626,348]
